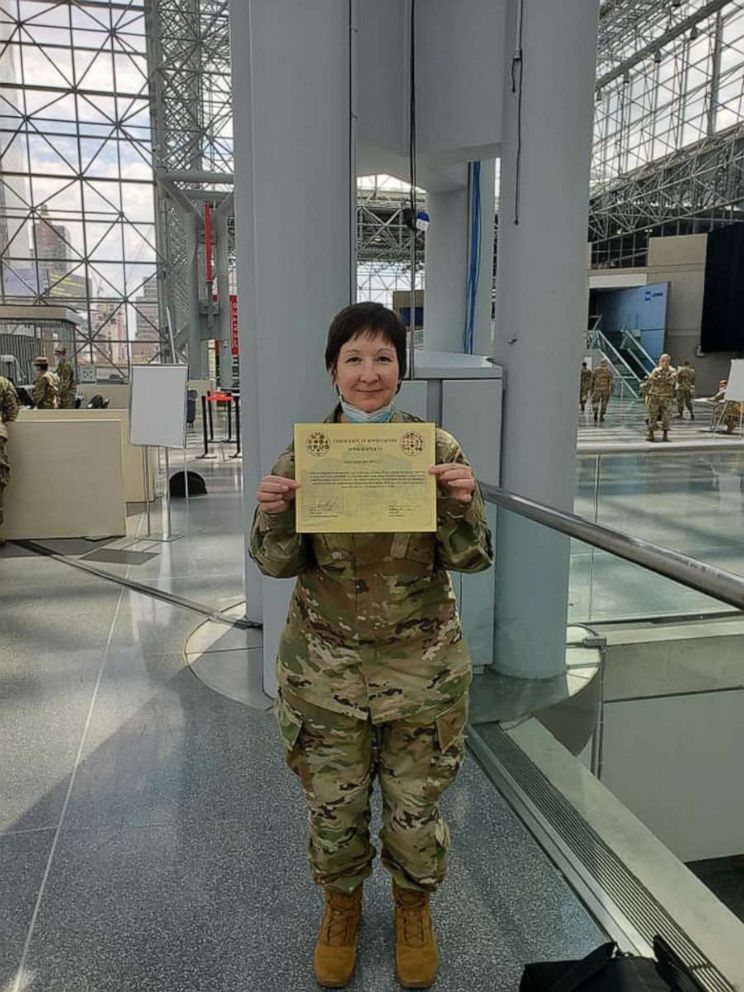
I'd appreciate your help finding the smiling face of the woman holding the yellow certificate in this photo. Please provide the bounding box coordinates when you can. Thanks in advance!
[332,331,400,413]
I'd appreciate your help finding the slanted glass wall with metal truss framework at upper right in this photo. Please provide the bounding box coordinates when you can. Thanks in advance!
[590,0,744,267]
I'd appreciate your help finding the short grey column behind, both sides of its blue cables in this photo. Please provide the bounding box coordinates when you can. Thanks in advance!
[424,161,495,355]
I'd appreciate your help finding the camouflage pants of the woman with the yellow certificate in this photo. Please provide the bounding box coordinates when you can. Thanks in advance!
[274,694,468,892]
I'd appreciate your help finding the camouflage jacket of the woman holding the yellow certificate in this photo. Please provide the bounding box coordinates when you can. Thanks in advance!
[250,411,493,723]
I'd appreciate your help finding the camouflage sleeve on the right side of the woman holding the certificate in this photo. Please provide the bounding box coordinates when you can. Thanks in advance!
[437,431,493,572]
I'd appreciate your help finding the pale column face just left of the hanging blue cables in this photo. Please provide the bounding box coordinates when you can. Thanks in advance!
[424,189,468,351]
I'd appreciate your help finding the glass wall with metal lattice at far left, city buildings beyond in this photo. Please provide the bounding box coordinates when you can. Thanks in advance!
[0,0,158,373]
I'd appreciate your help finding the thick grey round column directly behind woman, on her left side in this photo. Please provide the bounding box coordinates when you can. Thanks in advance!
[230,0,351,695]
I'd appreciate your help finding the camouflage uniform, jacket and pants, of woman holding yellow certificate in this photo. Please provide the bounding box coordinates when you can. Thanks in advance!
[251,411,493,892]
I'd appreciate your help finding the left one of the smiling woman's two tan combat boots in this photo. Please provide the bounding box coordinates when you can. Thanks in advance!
[313,885,362,989]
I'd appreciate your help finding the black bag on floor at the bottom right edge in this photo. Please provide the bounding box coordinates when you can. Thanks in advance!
[519,937,703,992]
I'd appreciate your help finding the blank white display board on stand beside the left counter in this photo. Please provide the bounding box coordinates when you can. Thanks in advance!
[129,365,188,448]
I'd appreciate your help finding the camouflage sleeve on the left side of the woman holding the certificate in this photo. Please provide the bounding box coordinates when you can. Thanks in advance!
[250,449,310,579]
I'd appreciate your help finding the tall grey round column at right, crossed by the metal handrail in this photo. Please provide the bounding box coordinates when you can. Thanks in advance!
[495,0,598,678]
